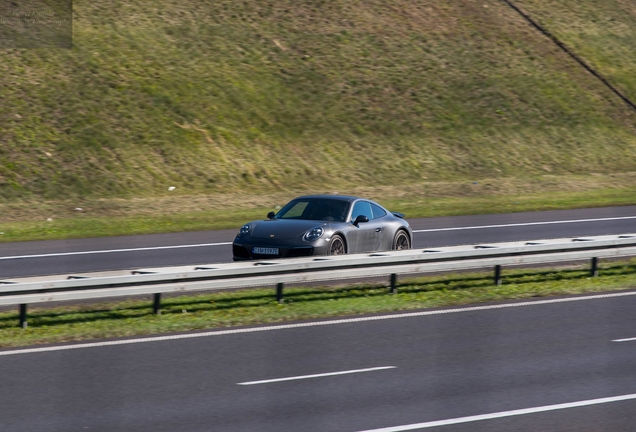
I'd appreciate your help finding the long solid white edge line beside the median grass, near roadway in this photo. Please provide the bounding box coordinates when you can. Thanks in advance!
[0,291,636,356]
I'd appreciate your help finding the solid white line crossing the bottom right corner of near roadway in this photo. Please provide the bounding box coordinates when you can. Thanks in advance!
[352,394,636,432]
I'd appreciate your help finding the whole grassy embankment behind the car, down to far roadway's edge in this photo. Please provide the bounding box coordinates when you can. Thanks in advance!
[0,0,636,241]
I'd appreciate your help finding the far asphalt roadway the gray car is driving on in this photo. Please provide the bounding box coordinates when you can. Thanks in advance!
[0,206,636,279]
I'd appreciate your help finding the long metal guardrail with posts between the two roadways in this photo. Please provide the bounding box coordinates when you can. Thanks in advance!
[0,234,636,328]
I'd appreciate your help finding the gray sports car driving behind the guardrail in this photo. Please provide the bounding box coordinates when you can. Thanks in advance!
[232,195,413,261]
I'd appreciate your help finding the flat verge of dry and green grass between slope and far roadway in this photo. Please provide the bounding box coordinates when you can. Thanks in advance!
[0,173,636,243]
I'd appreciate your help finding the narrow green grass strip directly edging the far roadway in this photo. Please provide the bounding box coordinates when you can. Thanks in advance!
[0,183,636,243]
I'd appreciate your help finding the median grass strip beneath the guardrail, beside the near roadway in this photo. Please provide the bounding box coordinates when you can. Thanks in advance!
[0,260,636,347]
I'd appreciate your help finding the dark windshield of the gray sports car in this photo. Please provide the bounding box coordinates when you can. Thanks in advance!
[276,198,349,222]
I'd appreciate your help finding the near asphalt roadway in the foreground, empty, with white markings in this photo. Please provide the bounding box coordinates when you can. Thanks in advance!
[0,291,636,432]
